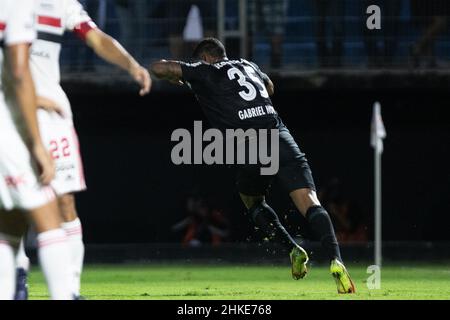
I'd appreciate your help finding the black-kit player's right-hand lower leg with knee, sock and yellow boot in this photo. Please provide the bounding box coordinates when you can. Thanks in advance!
[290,188,355,293]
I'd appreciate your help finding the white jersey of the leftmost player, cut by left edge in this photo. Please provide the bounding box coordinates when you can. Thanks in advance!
[0,0,36,129]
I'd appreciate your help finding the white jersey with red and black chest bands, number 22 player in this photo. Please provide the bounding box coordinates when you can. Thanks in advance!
[31,0,96,117]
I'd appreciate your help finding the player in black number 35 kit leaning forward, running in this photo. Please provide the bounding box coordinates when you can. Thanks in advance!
[151,38,355,293]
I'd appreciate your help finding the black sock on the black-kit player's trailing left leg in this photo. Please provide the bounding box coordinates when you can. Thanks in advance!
[249,201,298,250]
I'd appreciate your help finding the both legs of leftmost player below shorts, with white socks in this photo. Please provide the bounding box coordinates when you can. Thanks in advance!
[0,201,72,300]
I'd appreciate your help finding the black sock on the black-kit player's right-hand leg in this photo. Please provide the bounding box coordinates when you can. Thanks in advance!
[306,207,342,262]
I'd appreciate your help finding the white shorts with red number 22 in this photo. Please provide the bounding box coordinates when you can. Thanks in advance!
[38,110,86,196]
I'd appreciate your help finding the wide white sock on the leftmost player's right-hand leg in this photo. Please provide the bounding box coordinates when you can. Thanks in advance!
[37,229,73,300]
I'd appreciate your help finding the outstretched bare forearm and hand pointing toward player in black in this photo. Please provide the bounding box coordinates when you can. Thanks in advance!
[86,28,152,96]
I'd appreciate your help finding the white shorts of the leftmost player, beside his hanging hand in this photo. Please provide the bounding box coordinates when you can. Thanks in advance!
[0,126,55,210]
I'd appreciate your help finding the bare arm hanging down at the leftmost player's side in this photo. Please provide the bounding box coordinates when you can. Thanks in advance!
[6,43,55,184]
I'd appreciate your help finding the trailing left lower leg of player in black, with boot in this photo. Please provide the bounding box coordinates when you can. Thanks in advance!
[240,193,308,280]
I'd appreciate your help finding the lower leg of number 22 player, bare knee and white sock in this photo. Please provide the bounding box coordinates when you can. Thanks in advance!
[58,193,84,299]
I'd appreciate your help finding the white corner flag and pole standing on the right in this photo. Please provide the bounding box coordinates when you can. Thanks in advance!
[371,102,386,267]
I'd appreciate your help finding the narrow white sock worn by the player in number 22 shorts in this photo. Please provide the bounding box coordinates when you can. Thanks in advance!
[61,218,84,295]
